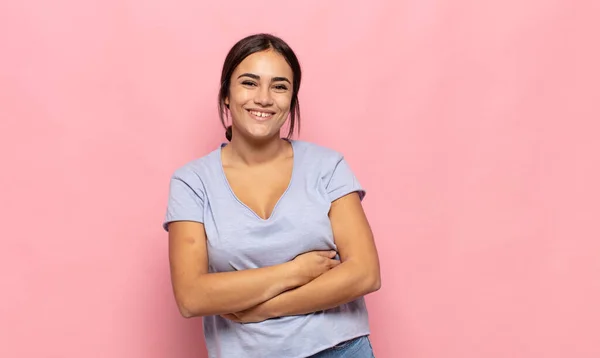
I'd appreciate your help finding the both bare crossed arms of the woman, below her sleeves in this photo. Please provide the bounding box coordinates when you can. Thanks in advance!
[169,193,381,323]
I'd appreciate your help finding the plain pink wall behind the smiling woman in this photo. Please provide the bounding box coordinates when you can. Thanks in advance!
[0,0,600,358]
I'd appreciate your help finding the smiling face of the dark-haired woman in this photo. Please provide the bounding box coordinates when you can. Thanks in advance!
[225,50,294,139]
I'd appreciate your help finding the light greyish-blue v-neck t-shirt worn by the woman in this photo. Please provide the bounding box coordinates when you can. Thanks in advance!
[163,140,370,358]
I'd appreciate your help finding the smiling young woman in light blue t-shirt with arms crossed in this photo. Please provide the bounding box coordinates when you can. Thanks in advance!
[163,34,380,358]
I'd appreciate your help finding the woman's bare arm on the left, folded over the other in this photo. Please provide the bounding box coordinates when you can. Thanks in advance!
[169,221,339,318]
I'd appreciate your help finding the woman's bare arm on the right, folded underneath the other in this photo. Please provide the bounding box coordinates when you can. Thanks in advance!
[224,192,381,323]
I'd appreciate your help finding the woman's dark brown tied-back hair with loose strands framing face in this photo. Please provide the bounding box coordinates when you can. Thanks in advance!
[219,34,302,141]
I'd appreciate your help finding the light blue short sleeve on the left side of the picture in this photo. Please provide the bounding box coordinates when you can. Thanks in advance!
[163,170,205,231]
